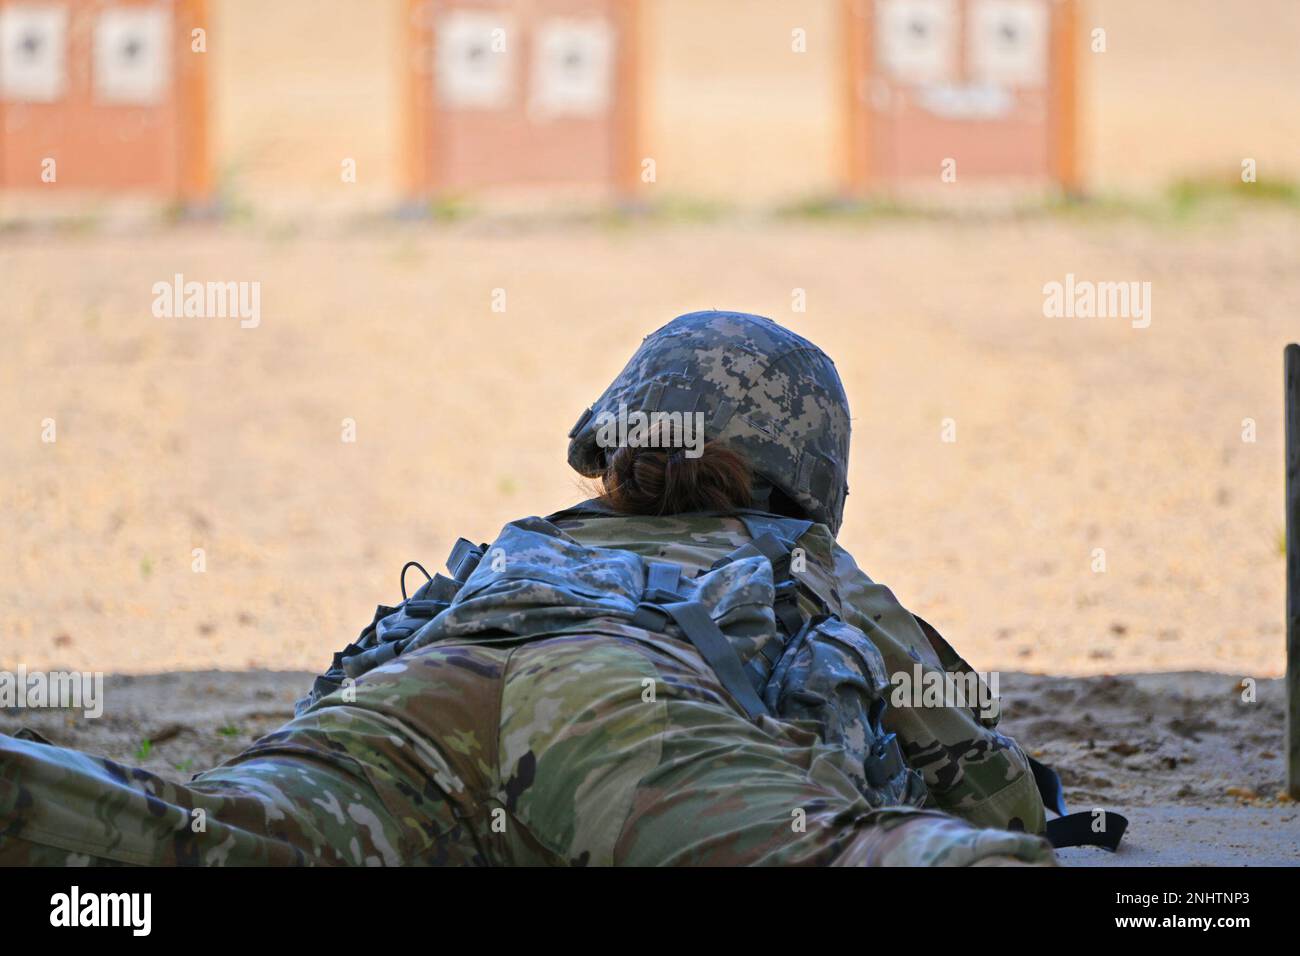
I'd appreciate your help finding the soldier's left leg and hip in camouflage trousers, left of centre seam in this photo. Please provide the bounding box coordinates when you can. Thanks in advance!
[0,648,504,865]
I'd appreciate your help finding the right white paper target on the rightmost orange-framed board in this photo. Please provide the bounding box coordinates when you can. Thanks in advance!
[966,0,1048,87]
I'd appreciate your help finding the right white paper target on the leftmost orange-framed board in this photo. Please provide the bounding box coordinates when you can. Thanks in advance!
[95,7,172,105]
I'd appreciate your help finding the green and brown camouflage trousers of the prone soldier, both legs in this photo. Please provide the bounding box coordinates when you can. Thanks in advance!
[0,633,1053,865]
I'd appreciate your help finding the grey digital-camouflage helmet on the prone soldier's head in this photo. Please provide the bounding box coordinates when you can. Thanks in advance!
[568,311,849,533]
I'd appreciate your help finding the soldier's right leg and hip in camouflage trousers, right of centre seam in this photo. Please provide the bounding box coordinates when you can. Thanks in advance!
[499,637,1052,865]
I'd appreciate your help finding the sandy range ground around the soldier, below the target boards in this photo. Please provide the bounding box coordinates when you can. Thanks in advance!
[0,209,1300,862]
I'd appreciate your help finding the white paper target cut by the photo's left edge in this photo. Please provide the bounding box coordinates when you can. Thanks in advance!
[0,4,68,103]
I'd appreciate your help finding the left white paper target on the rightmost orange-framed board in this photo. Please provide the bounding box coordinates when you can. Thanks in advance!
[876,0,958,86]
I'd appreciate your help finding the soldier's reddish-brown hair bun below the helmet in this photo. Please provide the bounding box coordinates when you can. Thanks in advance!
[601,429,754,515]
